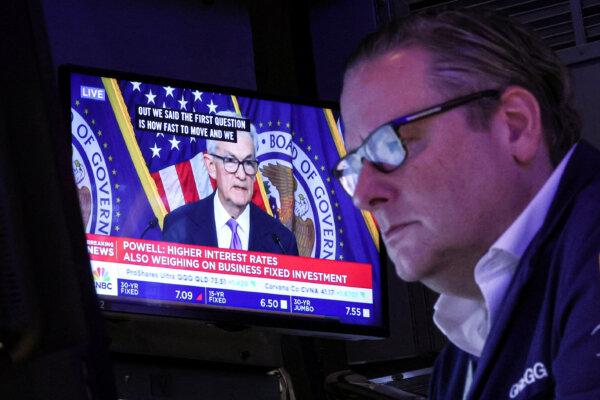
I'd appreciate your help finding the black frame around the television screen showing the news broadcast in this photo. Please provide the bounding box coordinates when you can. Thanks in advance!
[58,65,389,340]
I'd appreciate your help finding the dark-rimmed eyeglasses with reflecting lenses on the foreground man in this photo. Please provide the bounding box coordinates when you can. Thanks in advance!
[332,90,500,196]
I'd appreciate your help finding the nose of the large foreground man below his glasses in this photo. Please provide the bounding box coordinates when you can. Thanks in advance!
[352,161,392,211]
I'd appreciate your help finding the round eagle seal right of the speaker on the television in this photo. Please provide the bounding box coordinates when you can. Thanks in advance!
[256,131,337,260]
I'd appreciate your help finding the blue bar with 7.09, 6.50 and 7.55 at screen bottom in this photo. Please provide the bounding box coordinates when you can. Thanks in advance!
[117,279,373,323]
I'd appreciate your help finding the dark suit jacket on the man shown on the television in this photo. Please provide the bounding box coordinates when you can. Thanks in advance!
[163,192,298,255]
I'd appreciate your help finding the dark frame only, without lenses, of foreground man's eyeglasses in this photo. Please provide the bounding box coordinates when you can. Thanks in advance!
[331,89,502,196]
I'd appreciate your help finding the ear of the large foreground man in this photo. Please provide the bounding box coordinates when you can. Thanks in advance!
[500,86,544,165]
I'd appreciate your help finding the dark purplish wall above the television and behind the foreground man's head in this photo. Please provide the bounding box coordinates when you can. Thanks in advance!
[41,0,600,152]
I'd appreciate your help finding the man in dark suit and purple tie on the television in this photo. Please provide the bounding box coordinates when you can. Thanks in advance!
[163,122,298,255]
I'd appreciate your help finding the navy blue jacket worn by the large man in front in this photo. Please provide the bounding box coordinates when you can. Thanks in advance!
[430,142,600,400]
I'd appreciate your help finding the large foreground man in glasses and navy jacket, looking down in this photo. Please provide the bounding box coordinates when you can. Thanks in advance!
[336,7,600,399]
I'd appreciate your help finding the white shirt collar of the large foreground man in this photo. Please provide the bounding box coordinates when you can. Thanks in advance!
[433,146,575,357]
